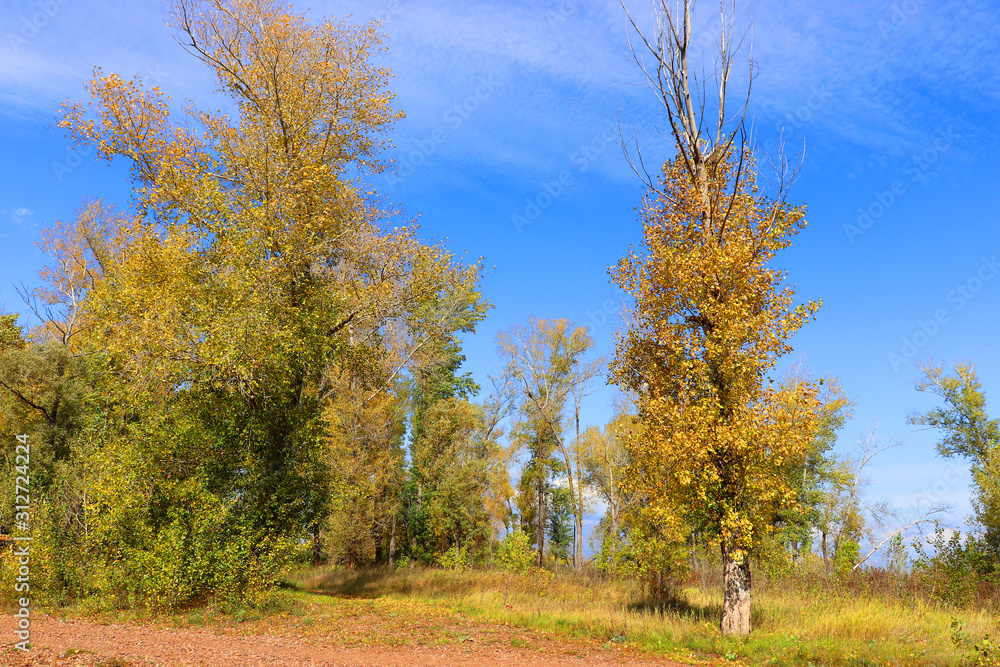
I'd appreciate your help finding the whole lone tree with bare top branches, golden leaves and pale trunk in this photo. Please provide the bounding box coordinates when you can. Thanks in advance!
[611,0,819,634]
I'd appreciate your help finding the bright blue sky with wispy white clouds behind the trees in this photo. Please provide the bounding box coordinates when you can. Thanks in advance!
[0,0,1000,552]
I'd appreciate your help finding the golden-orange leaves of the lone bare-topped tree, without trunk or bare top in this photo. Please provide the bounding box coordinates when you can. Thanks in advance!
[611,155,819,562]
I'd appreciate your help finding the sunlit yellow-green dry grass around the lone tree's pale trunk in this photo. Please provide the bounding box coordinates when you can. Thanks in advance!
[282,568,998,666]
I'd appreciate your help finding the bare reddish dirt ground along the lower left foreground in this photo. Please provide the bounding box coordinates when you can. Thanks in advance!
[0,614,700,667]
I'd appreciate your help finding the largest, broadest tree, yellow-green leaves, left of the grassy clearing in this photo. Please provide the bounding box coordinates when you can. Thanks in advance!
[40,0,483,603]
